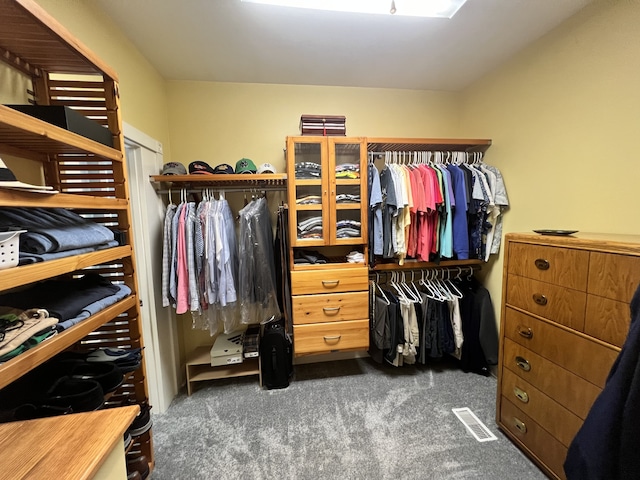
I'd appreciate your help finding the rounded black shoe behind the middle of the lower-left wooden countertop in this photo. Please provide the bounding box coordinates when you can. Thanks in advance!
[43,377,104,413]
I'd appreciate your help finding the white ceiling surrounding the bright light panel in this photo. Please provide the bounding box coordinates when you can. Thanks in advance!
[95,0,591,91]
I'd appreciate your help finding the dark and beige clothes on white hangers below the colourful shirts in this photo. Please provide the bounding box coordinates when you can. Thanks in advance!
[369,270,498,375]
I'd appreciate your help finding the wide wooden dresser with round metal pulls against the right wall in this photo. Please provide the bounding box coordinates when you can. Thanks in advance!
[496,233,640,478]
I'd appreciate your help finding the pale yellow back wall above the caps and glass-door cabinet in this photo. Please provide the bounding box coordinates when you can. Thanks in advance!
[167,81,459,172]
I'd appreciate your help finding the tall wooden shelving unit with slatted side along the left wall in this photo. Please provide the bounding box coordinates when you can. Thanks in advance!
[0,0,153,474]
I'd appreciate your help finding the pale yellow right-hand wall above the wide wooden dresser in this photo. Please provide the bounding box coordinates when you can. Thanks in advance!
[459,0,640,305]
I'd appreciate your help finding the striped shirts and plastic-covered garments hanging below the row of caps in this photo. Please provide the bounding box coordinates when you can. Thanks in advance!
[162,191,280,335]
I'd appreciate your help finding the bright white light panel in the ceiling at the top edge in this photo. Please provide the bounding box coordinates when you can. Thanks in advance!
[242,0,466,18]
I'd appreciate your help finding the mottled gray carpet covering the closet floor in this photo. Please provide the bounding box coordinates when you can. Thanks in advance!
[152,358,546,480]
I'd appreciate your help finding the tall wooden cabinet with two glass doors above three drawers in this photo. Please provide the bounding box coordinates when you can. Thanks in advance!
[287,136,369,356]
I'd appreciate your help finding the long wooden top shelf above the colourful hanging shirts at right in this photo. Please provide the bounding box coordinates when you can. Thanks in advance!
[367,137,491,153]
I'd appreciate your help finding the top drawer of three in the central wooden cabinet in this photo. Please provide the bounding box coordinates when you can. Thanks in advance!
[291,268,369,295]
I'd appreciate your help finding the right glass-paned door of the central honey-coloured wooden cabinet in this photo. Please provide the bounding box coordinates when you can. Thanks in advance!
[328,138,367,245]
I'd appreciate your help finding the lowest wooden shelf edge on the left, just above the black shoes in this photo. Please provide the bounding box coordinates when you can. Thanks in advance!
[0,297,136,388]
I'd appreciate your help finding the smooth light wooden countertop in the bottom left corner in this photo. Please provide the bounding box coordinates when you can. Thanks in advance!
[0,405,140,480]
